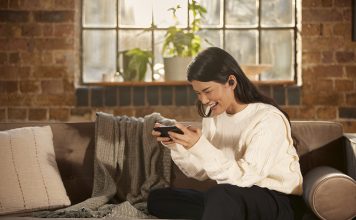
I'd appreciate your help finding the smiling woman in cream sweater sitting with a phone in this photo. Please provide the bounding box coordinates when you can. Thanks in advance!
[148,47,302,220]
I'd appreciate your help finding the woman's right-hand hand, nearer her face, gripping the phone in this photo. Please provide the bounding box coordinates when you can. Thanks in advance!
[168,123,201,149]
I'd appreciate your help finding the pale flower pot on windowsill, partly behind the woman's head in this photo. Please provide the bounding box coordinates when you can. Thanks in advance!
[163,57,193,81]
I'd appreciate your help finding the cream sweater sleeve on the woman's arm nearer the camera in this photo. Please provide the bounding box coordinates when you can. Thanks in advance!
[189,113,289,187]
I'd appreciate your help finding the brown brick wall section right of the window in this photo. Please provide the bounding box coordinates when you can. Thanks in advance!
[300,0,356,132]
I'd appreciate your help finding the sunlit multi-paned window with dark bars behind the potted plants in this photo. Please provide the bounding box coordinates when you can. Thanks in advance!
[82,0,299,83]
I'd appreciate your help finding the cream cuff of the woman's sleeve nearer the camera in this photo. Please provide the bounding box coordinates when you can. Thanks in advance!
[188,135,224,164]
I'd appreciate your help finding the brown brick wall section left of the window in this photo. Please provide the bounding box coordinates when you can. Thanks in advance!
[0,0,79,121]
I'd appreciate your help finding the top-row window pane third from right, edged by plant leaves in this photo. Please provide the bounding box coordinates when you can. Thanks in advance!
[197,0,223,27]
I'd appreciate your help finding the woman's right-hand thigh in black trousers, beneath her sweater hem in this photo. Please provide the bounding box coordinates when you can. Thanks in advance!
[203,184,293,220]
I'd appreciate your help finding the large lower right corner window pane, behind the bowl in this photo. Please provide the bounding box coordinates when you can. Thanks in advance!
[261,30,294,80]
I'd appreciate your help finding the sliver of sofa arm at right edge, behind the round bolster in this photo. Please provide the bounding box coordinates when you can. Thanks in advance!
[344,133,356,180]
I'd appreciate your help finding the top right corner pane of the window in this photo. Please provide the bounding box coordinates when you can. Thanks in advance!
[261,0,295,27]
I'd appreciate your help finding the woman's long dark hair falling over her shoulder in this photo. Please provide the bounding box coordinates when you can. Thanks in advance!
[187,47,290,123]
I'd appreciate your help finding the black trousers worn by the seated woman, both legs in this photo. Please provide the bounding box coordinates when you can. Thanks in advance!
[147,184,293,220]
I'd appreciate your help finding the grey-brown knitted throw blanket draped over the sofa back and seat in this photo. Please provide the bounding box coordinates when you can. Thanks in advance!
[34,112,173,218]
